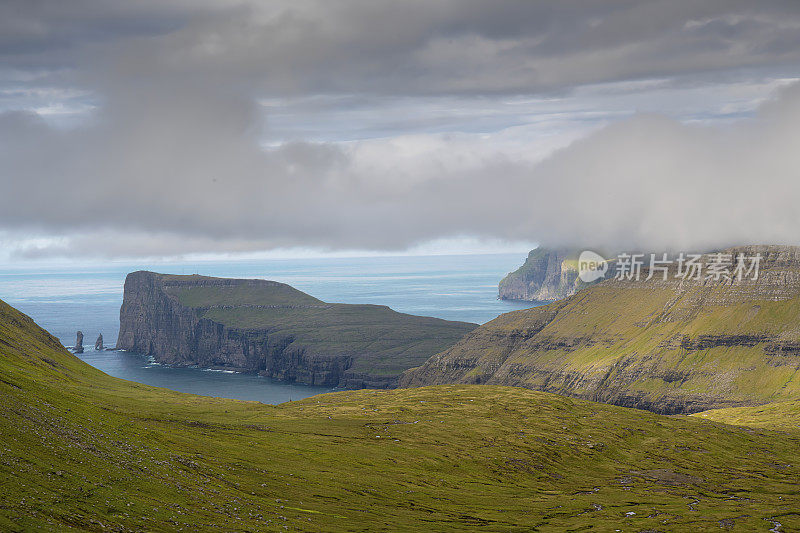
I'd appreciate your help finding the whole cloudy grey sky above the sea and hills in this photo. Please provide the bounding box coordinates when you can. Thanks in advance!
[0,0,800,263]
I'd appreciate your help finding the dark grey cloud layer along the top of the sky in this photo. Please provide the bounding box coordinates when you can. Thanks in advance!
[0,0,800,94]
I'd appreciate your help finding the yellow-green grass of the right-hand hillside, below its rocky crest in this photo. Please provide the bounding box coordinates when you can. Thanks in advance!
[410,266,800,412]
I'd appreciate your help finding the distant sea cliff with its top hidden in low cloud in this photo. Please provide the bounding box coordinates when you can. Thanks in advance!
[498,247,600,302]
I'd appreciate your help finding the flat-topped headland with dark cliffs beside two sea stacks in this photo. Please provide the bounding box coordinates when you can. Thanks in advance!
[117,272,476,388]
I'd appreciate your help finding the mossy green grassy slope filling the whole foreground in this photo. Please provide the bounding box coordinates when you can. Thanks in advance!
[0,302,800,531]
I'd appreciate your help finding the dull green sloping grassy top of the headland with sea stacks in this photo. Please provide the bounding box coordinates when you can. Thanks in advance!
[161,274,476,375]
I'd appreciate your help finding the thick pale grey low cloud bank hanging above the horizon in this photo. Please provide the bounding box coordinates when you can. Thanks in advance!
[0,81,800,255]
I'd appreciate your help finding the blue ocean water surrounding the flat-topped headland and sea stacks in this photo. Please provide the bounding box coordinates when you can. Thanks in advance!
[0,253,536,404]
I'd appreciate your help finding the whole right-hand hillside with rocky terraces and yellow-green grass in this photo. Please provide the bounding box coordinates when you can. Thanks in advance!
[401,246,800,413]
